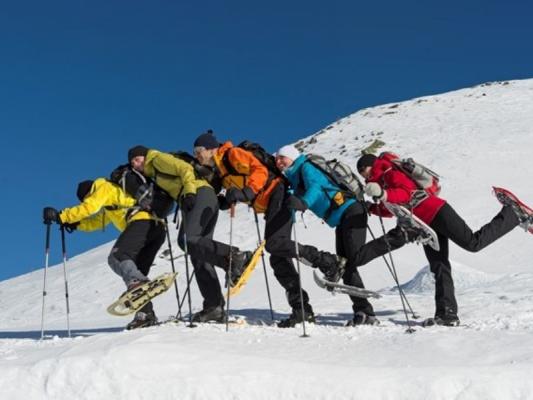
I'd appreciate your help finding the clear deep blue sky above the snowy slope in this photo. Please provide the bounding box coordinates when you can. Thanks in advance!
[0,0,533,279]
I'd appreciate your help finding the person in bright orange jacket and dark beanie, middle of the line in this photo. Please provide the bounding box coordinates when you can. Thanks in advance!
[194,131,346,328]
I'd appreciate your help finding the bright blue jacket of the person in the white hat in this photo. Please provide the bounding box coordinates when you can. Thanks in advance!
[285,154,356,227]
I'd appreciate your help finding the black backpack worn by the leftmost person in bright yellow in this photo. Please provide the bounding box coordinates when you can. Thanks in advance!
[109,164,174,218]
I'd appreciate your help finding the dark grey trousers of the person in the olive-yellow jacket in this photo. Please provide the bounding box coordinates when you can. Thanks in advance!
[178,187,238,309]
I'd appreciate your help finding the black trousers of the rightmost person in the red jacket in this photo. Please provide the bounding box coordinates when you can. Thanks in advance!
[424,203,519,316]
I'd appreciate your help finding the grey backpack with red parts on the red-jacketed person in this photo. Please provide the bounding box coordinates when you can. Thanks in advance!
[379,151,441,196]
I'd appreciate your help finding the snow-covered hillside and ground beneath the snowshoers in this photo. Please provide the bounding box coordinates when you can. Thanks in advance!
[0,80,533,400]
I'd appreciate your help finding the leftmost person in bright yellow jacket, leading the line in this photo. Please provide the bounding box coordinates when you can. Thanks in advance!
[44,178,165,329]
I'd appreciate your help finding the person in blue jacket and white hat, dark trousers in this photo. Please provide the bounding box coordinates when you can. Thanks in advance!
[276,145,414,325]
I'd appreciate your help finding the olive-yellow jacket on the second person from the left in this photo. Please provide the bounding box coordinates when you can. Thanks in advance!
[144,150,210,200]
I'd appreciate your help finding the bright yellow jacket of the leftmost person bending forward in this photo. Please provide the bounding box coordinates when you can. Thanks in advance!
[59,178,153,232]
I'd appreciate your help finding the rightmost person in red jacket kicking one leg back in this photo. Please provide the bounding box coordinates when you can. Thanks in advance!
[357,154,530,326]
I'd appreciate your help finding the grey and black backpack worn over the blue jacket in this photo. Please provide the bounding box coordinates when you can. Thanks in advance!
[300,154,363,199]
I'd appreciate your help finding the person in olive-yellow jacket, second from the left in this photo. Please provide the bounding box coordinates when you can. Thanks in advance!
[128,146,252,322]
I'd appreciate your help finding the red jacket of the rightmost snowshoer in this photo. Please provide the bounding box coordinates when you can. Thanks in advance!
[367,158,446,225]
